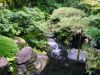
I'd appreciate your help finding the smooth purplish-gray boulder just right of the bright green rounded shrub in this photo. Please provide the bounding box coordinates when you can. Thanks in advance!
[17,46,35,64]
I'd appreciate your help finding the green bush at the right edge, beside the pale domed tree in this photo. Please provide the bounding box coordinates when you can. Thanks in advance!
[85,13,100,49]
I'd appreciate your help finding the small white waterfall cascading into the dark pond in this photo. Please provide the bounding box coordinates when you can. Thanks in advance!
[48,38,67,62]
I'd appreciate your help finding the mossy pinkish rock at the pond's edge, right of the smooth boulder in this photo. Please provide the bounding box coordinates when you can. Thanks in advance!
[27,53,48,74]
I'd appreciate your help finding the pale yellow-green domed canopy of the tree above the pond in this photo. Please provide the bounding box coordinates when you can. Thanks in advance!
[41,7,88,33]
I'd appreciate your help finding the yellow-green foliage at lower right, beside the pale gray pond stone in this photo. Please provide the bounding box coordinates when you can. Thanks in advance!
[87,48,100,71]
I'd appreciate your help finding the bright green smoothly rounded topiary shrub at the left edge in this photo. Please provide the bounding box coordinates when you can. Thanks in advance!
[0,36,19,57]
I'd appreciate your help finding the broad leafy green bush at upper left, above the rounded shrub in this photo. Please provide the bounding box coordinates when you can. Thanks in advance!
[0,7,45,36]
